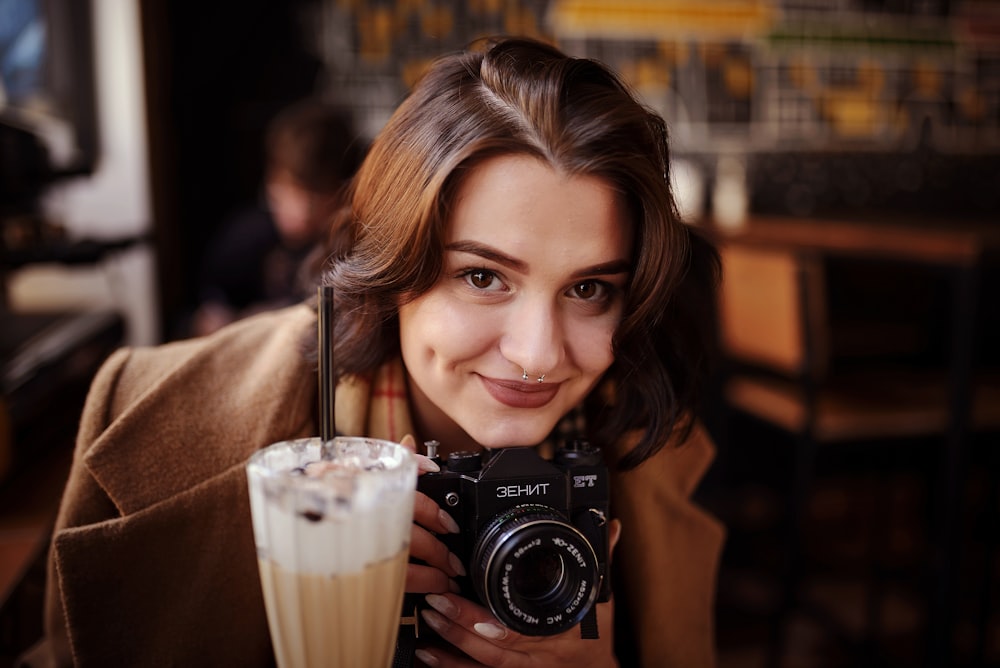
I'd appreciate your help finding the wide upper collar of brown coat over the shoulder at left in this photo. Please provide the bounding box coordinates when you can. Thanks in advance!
[84,307,316,515]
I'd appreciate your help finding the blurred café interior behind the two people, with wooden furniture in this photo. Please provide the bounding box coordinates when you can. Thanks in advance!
[0,0,1000,668]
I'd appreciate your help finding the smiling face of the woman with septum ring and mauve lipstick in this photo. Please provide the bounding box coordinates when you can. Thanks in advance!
[399,156,632,450]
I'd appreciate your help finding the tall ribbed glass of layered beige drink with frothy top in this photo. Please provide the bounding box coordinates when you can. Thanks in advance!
[247,437,417,668]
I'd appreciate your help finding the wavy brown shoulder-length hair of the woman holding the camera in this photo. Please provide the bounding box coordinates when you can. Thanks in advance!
[323,39,719,469]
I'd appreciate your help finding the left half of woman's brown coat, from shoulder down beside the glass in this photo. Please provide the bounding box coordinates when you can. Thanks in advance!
[51,307,316,666]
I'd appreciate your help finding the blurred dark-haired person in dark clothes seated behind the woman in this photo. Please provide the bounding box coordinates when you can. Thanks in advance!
[191,99,362,336]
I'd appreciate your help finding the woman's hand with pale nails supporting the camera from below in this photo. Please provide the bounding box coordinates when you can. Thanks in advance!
[417,520,621,668]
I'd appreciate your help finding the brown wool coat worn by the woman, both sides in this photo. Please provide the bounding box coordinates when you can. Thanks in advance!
[24,306,723,668]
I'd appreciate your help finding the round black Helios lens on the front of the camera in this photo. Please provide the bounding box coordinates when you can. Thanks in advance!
[470,505,600,636]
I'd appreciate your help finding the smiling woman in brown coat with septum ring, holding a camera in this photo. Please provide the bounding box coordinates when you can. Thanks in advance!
[23,40,722,667]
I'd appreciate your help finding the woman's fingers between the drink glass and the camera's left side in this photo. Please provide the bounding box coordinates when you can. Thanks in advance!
[400,434,465,594]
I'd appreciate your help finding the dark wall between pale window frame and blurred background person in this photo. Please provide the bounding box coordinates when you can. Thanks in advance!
[141,0,321,339]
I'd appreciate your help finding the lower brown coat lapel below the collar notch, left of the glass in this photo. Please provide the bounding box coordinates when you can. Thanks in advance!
[53,465,273,666]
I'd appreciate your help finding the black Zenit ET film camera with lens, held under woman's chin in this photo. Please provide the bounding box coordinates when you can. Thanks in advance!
[417,441,610,637]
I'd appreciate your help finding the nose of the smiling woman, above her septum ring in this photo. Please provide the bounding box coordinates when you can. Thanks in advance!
[500,302,565,378]
